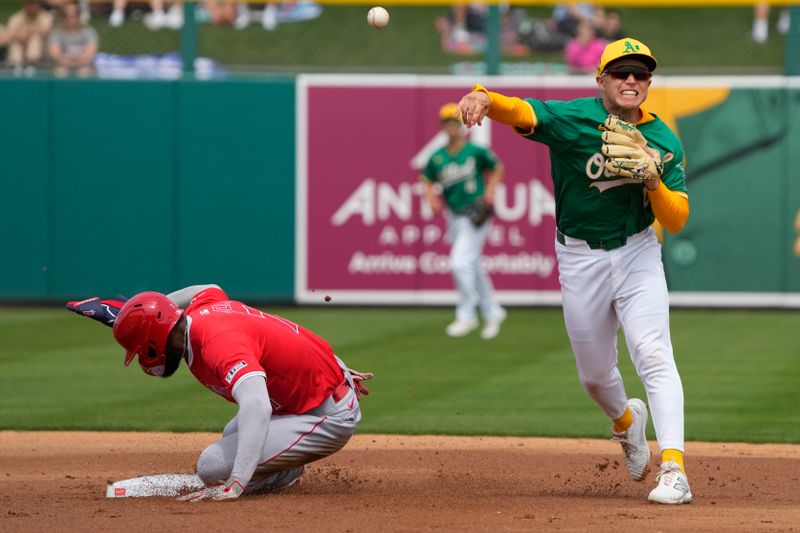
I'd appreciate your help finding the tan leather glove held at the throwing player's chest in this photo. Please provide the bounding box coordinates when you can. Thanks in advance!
[603,115,664,181]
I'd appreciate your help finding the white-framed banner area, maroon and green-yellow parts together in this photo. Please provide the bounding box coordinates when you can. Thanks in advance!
[295,76,800,308]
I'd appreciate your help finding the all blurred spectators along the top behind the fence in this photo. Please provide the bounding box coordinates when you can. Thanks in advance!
[0,0,790,76]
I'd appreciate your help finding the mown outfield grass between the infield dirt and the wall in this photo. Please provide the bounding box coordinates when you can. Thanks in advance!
[0,307,800,443]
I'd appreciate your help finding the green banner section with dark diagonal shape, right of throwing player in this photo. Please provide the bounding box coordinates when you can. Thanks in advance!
[664,89,800,292]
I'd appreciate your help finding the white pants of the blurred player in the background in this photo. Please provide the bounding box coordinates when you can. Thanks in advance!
[447,212,503,321]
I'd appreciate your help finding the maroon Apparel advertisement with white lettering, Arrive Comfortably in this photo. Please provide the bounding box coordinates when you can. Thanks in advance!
[296,77,594,303]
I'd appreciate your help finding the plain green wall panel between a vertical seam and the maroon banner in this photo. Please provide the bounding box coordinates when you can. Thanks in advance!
[176,79,294,301]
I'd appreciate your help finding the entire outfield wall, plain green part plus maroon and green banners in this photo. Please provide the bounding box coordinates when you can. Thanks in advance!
[0,76,800,307]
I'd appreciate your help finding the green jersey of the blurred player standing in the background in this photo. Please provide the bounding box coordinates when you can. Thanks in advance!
[422,142,497,214]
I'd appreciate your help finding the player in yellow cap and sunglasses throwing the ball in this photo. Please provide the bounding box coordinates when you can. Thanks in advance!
[459,38,692,504]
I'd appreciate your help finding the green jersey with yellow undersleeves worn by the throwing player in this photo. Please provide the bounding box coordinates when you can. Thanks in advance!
[525,98,686,241]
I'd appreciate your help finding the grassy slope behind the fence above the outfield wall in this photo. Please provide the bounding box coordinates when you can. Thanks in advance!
[0,0,786,74]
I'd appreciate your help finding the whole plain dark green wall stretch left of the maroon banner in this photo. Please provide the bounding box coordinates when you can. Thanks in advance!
[0,78,294,301]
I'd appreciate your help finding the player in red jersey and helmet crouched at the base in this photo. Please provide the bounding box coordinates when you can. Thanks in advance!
[67,285,372,501]
